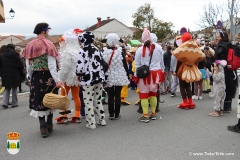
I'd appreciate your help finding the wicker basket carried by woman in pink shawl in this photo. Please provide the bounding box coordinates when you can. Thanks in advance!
[43,87,70,110]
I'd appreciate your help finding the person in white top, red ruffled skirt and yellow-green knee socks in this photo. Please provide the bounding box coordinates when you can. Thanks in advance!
[135,28,164,122]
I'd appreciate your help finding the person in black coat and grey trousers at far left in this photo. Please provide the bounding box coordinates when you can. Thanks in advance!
[0,44,23,109]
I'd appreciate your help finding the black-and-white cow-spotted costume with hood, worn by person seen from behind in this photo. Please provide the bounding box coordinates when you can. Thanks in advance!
[76,32,106,129]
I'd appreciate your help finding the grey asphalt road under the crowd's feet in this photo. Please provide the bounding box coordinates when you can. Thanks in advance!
[0,83,240,160]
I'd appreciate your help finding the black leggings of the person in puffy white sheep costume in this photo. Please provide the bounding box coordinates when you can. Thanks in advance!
[107,86,122,118]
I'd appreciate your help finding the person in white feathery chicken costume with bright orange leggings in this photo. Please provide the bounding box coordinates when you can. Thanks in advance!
[55,29,82,124]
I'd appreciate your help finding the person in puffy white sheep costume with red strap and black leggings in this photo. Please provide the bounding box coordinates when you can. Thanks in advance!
[103,33,130,120]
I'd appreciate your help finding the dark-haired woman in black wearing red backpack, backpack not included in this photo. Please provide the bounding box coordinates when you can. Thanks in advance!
[214,31,238,112]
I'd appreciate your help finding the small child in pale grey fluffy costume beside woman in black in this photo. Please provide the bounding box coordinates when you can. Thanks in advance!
[209,60,227,117]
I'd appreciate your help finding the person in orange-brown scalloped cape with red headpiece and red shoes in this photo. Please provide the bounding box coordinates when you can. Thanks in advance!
[172,32,205,109]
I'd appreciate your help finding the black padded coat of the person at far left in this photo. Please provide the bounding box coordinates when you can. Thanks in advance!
[0,49,23,87]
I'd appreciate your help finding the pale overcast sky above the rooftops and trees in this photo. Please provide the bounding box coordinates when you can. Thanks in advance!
[0,0,226,35]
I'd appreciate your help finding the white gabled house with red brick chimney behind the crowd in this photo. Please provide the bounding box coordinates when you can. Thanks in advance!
[85,17,134,39]
